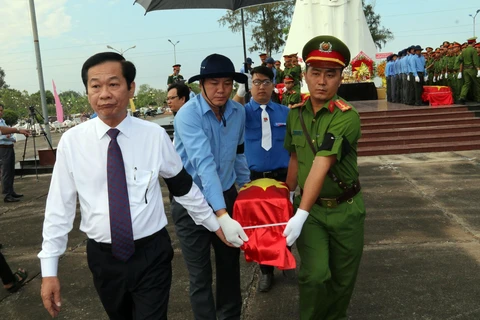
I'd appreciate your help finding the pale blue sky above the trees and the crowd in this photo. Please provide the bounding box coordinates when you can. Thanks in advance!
[0,0,480,93]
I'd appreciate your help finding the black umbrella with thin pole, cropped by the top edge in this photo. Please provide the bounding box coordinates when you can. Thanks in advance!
[135,0,285,75]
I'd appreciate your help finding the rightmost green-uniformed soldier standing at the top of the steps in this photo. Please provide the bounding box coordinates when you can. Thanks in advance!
[458,37,480,104]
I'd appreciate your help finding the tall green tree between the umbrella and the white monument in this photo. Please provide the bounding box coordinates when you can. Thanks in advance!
[218,0,295,56]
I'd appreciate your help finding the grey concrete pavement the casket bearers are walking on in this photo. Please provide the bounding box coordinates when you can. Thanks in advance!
[0,132,480,320]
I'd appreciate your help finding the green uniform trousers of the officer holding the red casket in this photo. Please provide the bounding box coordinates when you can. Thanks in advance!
[295,192,365,320]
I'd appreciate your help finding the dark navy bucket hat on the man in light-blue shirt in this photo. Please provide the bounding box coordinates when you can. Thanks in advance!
[188,53,248,83]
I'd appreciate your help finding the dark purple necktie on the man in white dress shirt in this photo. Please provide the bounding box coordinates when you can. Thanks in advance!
[107,129,135,261]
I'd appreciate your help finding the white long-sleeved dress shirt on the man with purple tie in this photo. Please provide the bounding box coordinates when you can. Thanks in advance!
[38,116,220,277]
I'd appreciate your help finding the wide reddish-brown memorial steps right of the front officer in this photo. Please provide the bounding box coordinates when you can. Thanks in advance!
[358,102,480,156]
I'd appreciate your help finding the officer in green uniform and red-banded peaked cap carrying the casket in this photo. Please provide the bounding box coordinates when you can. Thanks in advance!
[284,36,365,320]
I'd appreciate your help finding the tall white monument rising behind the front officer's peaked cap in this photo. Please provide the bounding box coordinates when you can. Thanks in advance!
[283,0,377,64]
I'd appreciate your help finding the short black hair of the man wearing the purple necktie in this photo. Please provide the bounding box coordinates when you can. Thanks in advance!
[82,52,137,93]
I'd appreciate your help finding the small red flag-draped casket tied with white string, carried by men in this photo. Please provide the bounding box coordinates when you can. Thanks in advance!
[233,178,296,270]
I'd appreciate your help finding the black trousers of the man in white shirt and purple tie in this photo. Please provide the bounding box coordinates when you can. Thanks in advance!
[87,228,173,320]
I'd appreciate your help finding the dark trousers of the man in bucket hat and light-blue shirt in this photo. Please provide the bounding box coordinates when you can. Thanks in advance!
[171,186,242,320]
